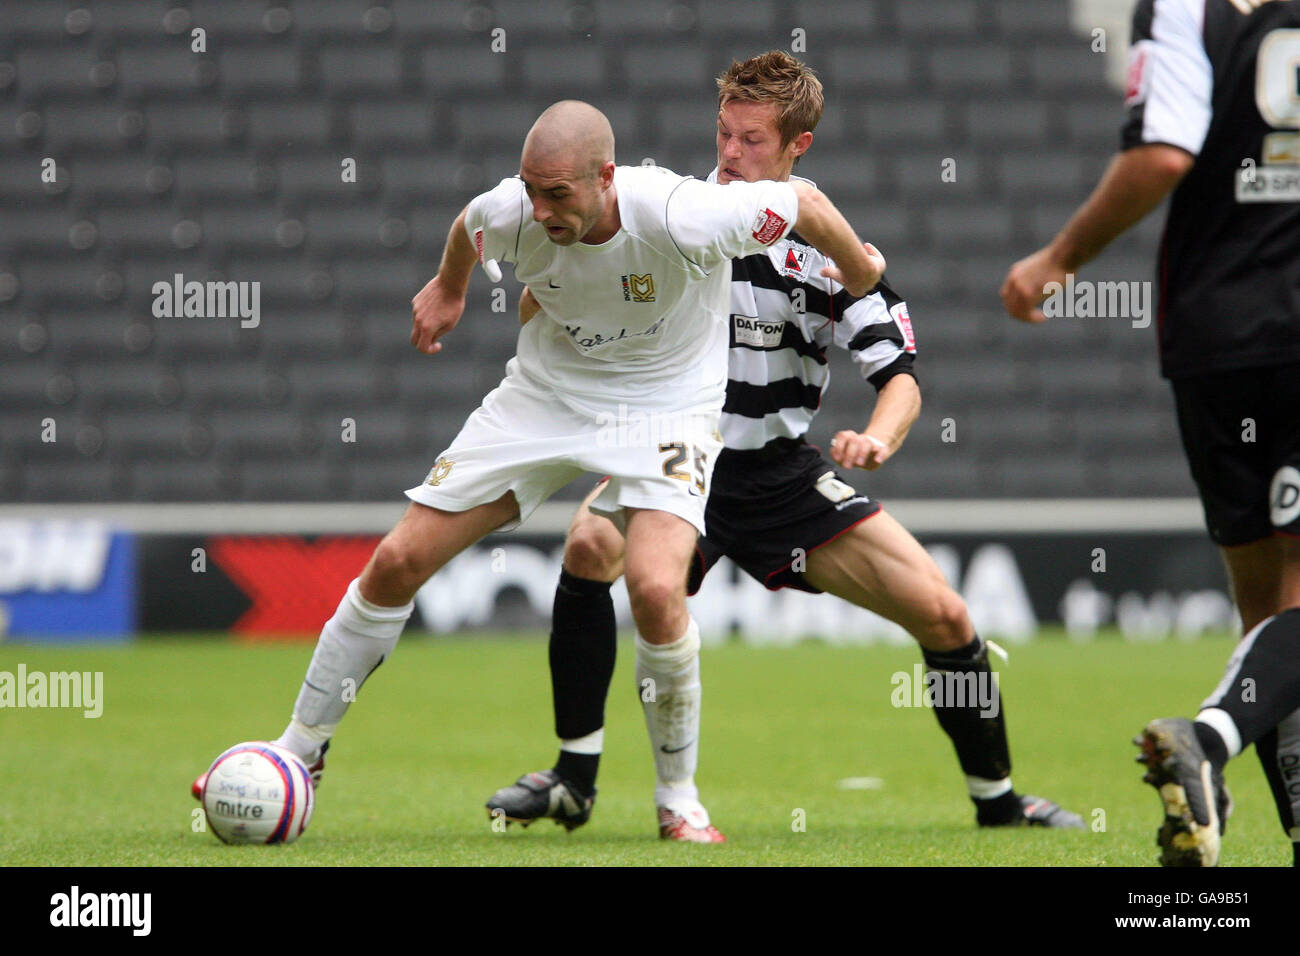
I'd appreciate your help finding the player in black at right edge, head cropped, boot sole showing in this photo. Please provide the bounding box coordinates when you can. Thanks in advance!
[1002,0,1300,866]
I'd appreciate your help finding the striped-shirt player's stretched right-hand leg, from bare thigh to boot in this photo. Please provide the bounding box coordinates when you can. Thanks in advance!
[803,511,1083,829]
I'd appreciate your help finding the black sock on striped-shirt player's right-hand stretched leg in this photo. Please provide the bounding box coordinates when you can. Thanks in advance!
[922,635,1011,780]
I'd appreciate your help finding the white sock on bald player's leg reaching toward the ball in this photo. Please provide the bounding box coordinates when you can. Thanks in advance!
[274,579,415,760]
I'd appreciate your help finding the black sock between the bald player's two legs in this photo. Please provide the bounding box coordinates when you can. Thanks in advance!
[550,571,618,793]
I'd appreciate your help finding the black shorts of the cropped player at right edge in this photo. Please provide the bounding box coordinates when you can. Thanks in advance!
[1173,364,1300,548]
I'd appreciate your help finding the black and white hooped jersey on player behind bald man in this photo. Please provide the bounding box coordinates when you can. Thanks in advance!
[709,169,917,449]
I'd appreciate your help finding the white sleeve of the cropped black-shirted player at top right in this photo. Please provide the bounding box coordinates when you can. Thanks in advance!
[1123,0,1214,156]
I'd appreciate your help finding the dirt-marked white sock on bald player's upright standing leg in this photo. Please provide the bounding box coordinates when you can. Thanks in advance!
[636,618,701,806]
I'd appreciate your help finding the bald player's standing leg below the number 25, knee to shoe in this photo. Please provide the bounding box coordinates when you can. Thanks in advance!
[624,509,724,843]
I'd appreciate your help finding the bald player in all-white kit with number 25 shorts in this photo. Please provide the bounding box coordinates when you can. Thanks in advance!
[192,100,885,827]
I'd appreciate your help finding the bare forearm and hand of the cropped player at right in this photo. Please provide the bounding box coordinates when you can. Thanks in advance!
[1002,143,1196,323]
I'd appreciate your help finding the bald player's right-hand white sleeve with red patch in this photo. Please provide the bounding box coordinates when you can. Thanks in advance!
[664,179,800,269]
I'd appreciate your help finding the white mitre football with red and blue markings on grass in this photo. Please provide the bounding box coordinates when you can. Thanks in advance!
[200,740,316,843]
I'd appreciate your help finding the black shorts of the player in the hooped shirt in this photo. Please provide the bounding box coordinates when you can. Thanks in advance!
[686,438,880,594]
